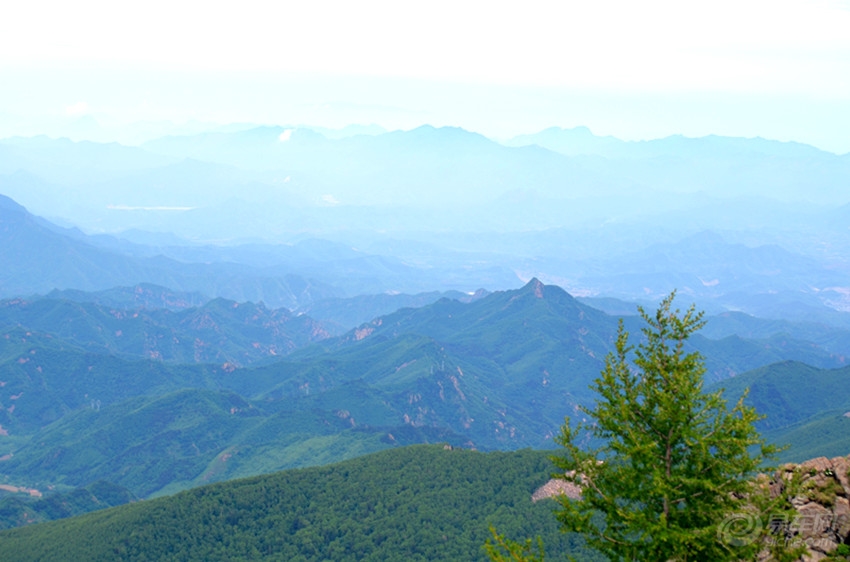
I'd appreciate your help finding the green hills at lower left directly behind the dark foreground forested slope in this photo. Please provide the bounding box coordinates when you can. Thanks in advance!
[0,389,465,497]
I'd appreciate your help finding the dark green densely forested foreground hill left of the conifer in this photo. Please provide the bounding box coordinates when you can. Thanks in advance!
[0,445,598,562]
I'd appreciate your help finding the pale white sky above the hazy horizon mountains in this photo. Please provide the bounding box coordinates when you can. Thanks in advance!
[0,0,850,154]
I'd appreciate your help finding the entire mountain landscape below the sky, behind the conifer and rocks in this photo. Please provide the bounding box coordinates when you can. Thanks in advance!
[0,125,850,560]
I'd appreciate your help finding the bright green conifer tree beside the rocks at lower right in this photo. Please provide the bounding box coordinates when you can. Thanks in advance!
[553,293,775,561]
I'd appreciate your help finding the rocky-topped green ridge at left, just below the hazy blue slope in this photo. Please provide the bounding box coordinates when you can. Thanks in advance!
[0,296,331,366]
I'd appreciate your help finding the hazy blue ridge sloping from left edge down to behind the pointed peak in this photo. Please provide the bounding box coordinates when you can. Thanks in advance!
[0,190,517,302]
